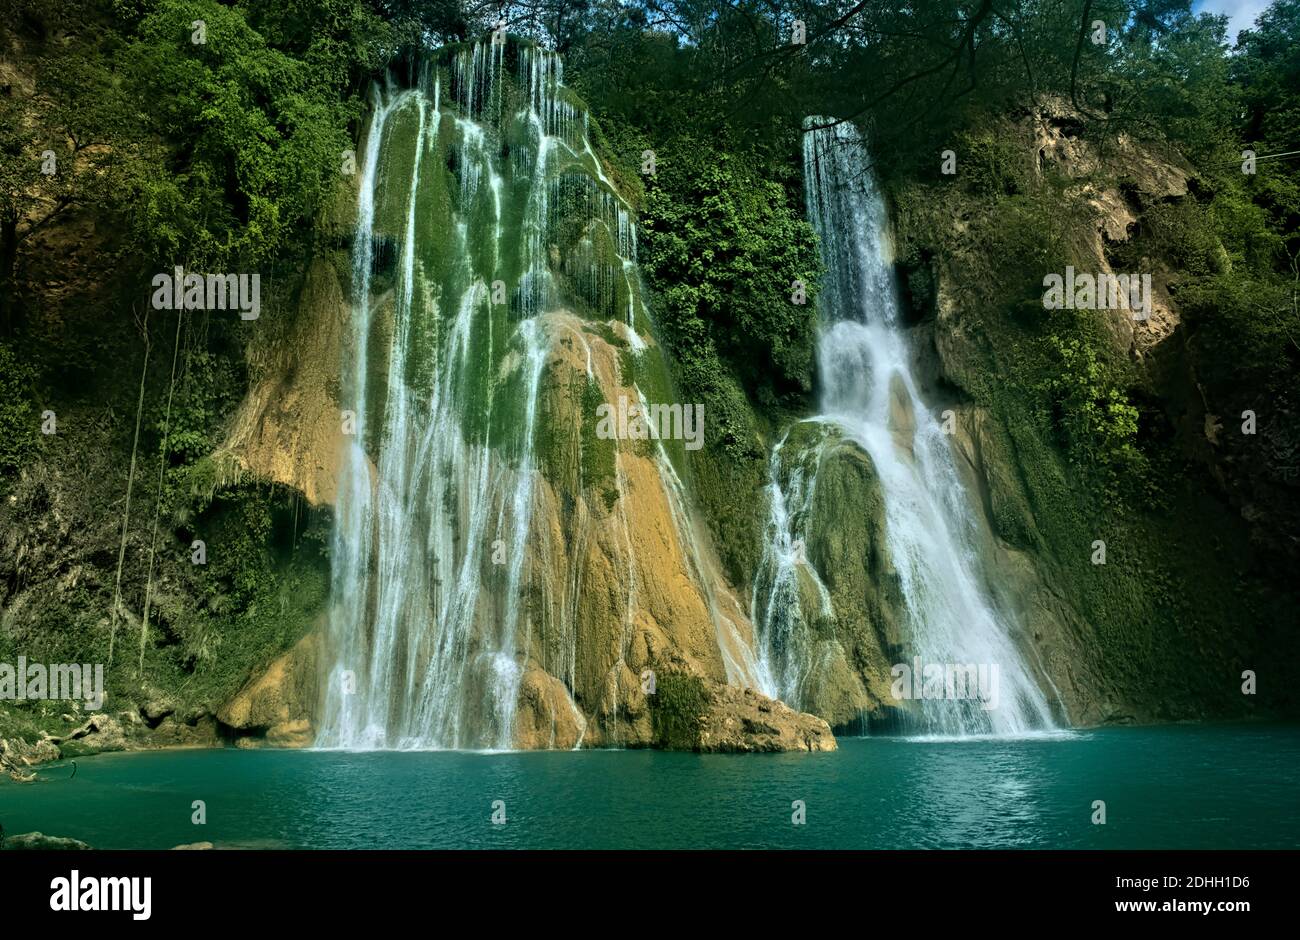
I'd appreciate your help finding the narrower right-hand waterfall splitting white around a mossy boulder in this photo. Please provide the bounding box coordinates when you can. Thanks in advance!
[753,118,1053,735]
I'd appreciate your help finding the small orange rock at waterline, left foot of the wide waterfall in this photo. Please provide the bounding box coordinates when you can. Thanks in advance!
[217,633,320,748]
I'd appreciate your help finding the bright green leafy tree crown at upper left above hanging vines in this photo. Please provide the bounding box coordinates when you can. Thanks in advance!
[122,0,380,269]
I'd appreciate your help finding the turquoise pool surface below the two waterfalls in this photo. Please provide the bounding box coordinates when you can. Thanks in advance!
[0,725,1300,849]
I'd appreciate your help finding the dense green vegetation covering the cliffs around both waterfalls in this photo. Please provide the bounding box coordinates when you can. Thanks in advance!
[0,0,1300,733]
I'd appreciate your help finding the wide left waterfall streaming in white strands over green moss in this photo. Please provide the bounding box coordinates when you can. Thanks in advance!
[317,40,644,749]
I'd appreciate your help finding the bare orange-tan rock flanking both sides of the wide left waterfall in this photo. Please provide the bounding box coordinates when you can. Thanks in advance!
[219,214,790,748]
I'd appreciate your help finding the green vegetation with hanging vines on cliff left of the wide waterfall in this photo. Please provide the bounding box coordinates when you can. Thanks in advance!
[0,0,371,711]
